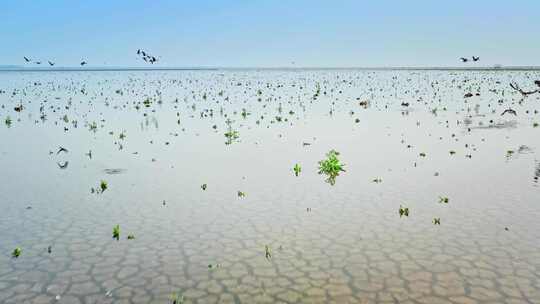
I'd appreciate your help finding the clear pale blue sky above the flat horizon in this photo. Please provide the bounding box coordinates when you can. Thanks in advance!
[0,0,540,67]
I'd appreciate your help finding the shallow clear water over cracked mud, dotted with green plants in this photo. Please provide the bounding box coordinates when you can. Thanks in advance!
[0,70,540,303]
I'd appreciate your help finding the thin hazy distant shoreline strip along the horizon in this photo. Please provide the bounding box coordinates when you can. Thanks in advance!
[0,66,540,72]
